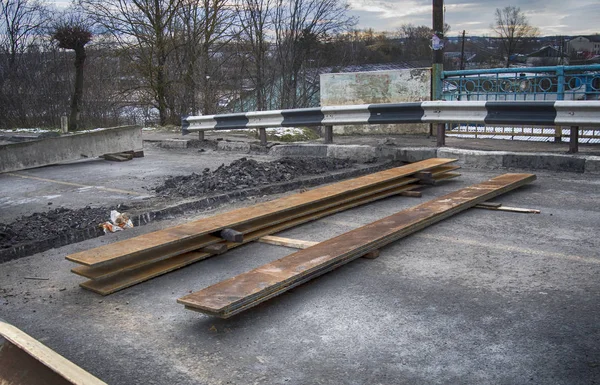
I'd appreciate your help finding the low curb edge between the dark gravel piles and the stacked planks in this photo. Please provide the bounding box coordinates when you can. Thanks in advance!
[0,162,395,264]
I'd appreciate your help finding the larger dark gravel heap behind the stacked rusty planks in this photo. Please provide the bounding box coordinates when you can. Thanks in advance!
[155,158,354,197]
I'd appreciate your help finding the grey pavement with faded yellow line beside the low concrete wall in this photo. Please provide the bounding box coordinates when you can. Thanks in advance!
[0,145,272,223]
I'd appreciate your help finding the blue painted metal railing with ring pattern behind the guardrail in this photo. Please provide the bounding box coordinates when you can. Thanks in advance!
[440,64,600,143]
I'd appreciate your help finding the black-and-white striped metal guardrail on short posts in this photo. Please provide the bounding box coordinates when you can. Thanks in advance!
[182,101,600,152]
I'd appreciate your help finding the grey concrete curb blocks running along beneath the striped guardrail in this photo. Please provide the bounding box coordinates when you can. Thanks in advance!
[144,131,600,174]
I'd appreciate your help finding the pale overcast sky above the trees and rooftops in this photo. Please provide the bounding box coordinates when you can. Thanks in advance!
[54,0,600,36]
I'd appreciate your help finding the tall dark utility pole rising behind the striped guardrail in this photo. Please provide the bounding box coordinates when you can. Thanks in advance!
[431,0,446,147]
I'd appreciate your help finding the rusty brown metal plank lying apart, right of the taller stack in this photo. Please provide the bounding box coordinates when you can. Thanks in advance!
[177,174,536,318]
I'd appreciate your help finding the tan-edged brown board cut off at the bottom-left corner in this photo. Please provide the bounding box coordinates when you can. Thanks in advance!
[0,321,106,385]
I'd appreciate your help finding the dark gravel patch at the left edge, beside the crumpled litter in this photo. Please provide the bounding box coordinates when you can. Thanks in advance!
[0,206,125,249]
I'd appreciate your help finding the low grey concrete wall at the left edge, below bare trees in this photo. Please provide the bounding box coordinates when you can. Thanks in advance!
[0,126,143,172]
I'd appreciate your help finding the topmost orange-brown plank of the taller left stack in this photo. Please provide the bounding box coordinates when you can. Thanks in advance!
[66,158,455,266]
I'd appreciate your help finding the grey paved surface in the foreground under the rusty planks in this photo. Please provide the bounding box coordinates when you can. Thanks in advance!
[0,169,600,385]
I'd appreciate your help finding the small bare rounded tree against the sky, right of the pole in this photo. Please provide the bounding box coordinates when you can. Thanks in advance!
[492,6,539,68]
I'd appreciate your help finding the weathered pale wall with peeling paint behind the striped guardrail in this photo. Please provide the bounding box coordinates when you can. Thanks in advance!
[321,68,431,134]
